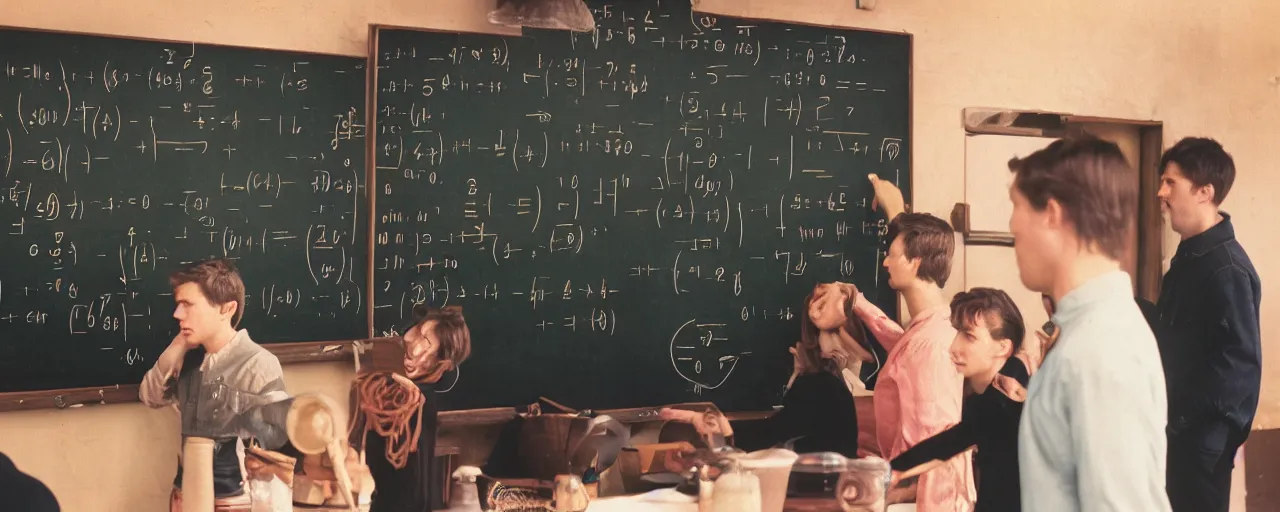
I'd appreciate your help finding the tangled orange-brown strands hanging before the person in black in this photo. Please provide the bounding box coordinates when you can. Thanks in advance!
[356,371,426,470]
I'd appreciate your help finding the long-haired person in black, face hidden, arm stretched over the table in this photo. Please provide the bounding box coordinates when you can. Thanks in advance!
[662,283,884,458]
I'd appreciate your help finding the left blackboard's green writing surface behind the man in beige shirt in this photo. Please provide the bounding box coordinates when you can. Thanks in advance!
[0,29,369,392]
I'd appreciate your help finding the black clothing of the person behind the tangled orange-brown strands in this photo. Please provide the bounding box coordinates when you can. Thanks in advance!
[365,383,443,512]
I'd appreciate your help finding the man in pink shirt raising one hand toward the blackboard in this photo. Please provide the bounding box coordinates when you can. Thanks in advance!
[850,175,977,512]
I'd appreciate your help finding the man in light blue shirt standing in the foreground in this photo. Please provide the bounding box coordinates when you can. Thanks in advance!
[1009,136,1170,512]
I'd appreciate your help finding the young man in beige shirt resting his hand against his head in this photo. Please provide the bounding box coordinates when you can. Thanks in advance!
[138,260,288,511]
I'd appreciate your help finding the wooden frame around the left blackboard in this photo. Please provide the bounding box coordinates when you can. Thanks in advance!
[0,24,376,412]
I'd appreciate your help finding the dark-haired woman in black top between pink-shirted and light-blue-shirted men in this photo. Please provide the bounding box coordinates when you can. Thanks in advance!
[890,288,1030,512]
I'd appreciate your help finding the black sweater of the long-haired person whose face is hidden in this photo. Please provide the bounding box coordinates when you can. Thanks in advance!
[733,371,858,458]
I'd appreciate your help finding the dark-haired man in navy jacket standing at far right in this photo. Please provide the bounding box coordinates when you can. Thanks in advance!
[1152,137,1262,512]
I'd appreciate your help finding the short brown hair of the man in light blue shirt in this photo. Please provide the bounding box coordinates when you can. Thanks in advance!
[1009,134,1138,260]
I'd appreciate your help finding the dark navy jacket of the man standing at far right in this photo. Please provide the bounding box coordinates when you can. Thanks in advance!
[1152,212,1262,448]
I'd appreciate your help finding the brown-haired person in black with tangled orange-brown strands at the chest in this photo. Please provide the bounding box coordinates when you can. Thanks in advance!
[351,306,471,512]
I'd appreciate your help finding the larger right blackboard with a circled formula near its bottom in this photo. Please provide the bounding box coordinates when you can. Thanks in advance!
[374,1,911,410]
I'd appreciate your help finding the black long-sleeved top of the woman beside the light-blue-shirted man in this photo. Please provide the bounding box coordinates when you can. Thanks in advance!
[890,357,1028,512]
